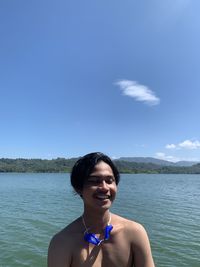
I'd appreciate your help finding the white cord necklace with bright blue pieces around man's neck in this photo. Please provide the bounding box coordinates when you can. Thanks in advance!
[82,216,113,246]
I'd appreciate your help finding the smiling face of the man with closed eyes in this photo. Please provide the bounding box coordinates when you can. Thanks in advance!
[81,161,117,213]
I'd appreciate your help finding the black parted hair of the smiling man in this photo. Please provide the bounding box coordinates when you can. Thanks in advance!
[71,152,120,194]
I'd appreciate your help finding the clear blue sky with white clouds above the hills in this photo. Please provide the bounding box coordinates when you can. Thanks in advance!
[0,0,200,161]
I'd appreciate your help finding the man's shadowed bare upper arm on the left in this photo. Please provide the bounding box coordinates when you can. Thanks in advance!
[47,236,71,267]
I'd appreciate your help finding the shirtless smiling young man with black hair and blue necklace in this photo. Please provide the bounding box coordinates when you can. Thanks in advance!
[48,152,154,267]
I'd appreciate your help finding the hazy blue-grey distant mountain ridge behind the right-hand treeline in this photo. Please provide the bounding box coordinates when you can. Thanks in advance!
[119,157,198,167]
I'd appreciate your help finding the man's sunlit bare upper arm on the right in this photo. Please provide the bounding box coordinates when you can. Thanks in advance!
[133,225,155,267]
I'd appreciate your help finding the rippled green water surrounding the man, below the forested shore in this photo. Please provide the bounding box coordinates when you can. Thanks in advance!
[0,173,200,267]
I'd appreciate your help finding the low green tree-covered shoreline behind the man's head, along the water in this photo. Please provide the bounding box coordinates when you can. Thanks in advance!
[0,158,200,174]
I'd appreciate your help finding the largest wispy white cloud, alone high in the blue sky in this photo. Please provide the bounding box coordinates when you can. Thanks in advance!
[115,80,160,105]
